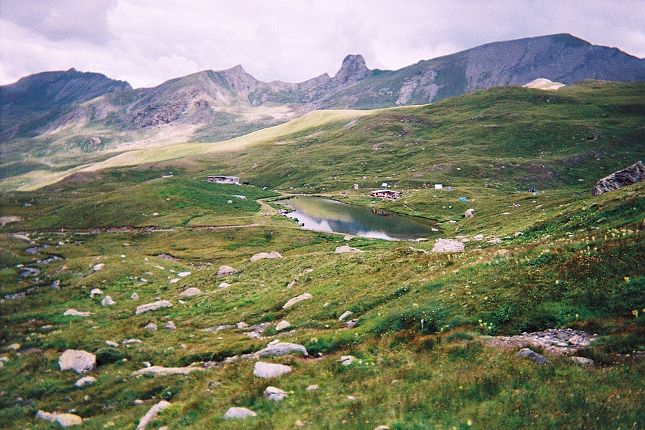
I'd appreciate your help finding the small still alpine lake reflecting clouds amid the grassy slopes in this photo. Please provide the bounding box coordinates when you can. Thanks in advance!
[280,196,438,240]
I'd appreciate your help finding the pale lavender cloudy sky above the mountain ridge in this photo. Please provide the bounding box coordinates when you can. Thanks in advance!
[0,0,645,87]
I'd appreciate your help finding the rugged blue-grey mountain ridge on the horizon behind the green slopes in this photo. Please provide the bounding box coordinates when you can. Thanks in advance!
[0,34,645,149]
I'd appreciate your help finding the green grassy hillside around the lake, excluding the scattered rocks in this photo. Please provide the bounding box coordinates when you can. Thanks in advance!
[0,83,645,429]
